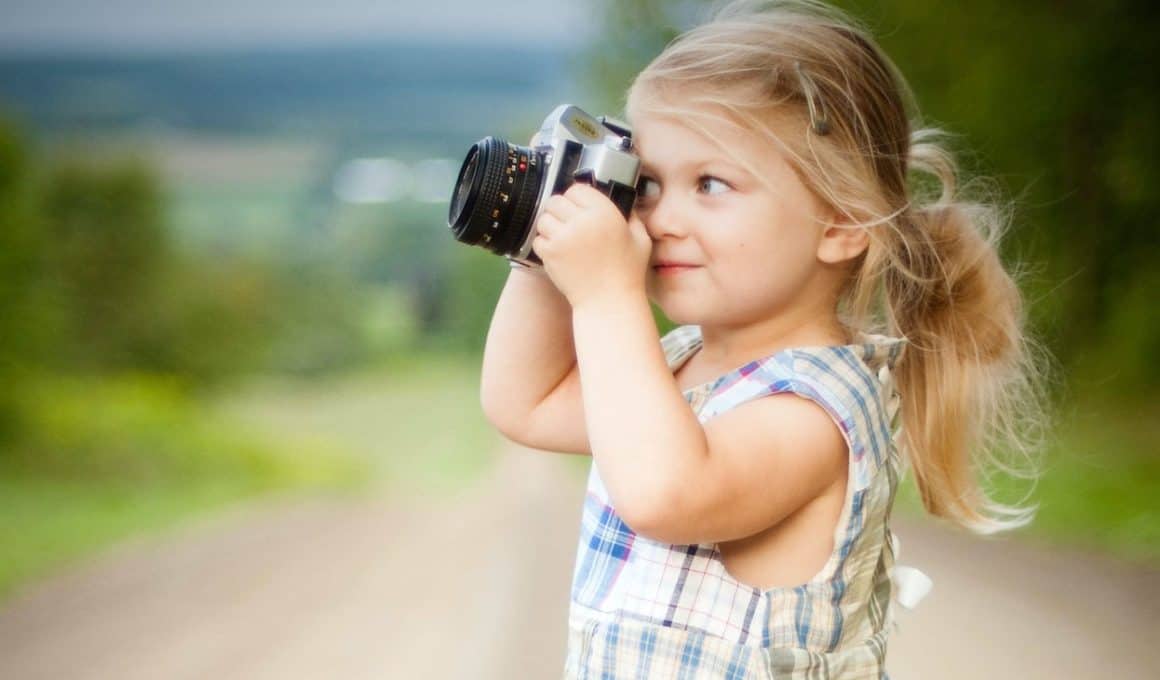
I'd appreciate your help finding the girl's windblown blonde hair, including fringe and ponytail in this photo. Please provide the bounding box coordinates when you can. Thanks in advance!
[626,0,1043,533]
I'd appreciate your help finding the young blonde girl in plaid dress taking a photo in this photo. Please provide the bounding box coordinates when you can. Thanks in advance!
[483,1,1036,679]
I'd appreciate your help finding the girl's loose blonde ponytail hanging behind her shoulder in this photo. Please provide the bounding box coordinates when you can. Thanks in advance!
[863,130,1042,533]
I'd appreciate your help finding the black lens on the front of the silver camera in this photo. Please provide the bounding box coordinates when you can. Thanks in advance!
[448,137,544,255]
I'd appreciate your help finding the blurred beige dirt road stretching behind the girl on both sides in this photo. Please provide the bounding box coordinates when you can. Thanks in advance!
[0,450,1160,680]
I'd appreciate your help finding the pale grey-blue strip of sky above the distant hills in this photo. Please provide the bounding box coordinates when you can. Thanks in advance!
[0,0,599,51]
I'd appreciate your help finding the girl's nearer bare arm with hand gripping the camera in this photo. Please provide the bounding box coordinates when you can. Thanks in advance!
[534,185,848,543]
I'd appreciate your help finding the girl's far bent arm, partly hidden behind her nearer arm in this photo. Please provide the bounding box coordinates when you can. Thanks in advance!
[480,269,589,454]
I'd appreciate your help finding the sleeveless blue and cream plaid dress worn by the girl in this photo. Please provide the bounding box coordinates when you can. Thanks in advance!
[565,326,904,680]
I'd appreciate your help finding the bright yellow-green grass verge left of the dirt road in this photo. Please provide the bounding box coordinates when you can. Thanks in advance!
[0,376,362,599]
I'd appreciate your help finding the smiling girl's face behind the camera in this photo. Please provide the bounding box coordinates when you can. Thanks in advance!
[633,111,828,326]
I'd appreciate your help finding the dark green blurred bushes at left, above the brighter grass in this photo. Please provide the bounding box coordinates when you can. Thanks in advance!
[0,114,378,387]
